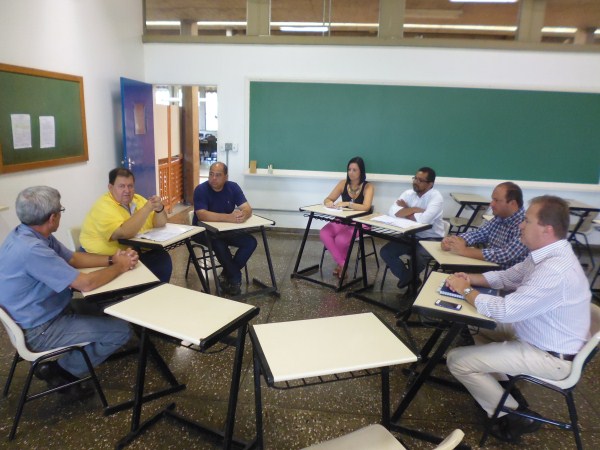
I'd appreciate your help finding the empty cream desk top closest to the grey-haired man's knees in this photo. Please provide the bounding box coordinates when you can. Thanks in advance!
[104,284,256,345]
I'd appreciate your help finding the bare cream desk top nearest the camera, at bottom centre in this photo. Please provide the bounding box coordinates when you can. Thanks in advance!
[252,313,417,382]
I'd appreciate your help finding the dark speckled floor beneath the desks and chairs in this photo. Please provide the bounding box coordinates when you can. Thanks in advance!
[0,216,600,449]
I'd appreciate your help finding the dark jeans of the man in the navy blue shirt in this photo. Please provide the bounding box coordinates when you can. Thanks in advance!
[195,233,257,283]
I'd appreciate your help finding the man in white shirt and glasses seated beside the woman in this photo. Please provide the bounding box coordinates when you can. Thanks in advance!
[380,167,444,296]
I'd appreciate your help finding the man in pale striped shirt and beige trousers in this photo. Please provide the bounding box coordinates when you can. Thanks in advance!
[446,196,591,442]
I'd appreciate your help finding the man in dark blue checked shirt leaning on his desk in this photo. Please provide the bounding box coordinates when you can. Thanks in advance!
[442,181,528,269]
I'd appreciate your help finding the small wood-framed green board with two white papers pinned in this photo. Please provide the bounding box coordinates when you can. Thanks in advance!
[0,64,88,173]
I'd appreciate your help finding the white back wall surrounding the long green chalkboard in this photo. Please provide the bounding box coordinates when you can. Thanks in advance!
[144,44,600,241]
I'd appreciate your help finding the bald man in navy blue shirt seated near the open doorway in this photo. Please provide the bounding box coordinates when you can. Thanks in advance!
[193,162,256,295]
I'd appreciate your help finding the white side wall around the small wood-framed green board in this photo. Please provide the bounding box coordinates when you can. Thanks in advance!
[0,0,144,243]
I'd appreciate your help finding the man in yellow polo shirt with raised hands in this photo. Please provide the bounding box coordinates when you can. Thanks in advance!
[79,168,173,283]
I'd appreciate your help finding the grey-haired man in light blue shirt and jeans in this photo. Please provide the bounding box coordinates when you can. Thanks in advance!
[0,186,138,396]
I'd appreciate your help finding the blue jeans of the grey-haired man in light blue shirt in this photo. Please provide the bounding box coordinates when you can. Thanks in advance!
[23,307,131,377]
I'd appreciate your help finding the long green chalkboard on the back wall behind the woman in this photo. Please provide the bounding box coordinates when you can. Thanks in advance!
[249,82,600,184]
